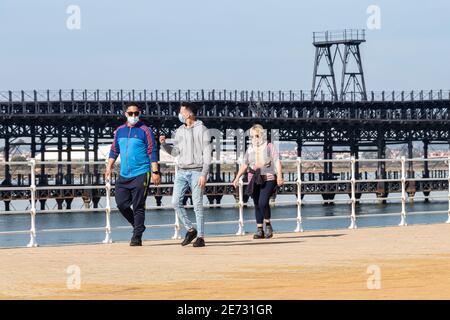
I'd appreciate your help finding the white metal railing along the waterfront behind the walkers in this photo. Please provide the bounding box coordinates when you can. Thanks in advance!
[0,156,450,247]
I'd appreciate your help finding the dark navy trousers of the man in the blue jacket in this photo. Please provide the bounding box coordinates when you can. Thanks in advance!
[115,172,150,237]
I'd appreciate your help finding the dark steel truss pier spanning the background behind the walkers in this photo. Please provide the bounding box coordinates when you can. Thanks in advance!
[0,90,450,210]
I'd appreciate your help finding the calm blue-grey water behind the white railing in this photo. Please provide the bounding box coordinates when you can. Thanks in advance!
[0,192,448,247]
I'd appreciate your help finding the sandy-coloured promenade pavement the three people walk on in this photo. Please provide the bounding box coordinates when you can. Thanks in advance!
[0,224,450,299]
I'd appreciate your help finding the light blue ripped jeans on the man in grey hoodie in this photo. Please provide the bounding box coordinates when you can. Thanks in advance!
[172,169,205,237]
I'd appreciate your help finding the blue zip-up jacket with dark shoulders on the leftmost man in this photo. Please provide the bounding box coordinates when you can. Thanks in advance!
[109,121,158,178]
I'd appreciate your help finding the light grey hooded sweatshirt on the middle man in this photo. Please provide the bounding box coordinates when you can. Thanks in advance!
[161,120,212,177]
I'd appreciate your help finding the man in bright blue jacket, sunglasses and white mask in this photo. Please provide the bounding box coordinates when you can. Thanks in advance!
[105,103,160,246]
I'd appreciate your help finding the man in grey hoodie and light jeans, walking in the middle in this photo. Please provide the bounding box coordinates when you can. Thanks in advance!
[159,102,212,247]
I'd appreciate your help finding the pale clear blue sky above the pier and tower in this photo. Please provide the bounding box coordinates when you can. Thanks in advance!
[0,0,450,90]
